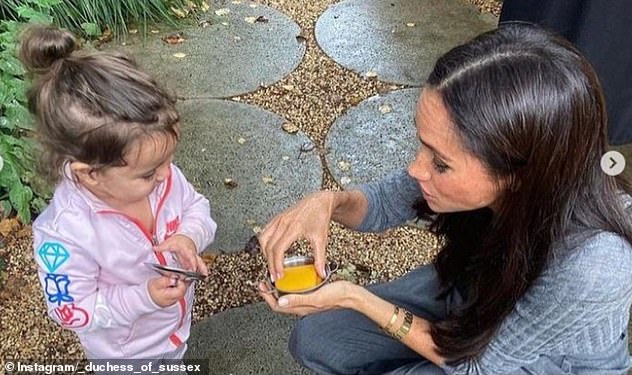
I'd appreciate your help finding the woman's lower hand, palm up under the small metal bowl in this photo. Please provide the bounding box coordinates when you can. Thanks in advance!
[259,280,364,316]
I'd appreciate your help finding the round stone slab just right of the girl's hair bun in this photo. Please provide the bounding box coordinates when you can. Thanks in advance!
[108,1,305,98]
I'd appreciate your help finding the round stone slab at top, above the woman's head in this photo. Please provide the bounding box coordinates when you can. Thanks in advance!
[315,0,498,86]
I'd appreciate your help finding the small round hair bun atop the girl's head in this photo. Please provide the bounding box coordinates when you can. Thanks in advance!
[20,25,77,73]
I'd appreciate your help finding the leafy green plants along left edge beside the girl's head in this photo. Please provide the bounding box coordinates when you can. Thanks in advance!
[0,0,53,223]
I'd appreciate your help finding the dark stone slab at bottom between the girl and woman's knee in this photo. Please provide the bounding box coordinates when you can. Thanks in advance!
[185,302,313,375]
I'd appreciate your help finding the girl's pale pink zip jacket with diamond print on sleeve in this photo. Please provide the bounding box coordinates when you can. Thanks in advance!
[33,165,217,359]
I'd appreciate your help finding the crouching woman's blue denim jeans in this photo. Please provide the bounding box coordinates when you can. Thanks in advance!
[289,265,629,375]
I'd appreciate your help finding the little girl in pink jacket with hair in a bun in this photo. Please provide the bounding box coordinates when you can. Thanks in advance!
[20,26,216,359]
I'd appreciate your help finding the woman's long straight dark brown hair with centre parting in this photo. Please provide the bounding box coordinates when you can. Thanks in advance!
[418,24,632,363]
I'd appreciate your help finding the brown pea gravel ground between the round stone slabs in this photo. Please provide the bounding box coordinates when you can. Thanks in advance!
[0,0,501,364]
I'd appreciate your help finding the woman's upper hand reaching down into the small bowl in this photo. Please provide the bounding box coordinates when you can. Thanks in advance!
[259,191,335,280]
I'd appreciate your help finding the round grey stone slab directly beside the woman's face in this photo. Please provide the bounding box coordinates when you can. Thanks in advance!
[325,88,421,187]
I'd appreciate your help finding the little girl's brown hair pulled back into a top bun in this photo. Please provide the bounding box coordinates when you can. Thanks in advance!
[20,25,179,182]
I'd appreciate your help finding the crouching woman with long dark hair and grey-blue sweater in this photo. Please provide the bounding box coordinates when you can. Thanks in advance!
[260,24,632,374]
